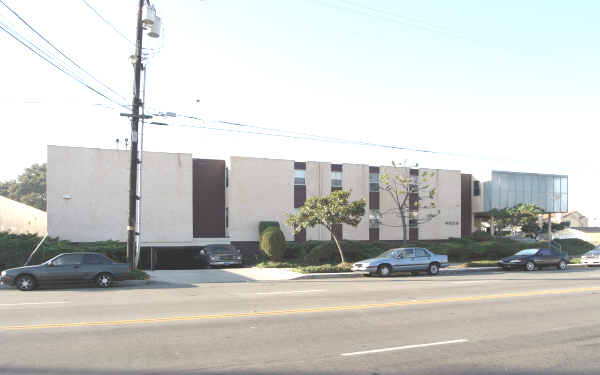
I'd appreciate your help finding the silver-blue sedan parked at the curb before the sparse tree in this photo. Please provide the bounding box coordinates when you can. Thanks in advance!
[351,248,448,277]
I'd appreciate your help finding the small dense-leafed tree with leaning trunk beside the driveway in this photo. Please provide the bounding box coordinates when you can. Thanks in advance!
[287,190,367,263]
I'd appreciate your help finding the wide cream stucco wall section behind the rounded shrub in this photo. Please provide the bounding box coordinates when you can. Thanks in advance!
[228,157,294,241]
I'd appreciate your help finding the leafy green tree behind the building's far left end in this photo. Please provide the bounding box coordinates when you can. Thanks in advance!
[0,164,46,211]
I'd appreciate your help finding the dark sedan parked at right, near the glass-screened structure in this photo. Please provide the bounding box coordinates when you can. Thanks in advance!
[498,249,569,271]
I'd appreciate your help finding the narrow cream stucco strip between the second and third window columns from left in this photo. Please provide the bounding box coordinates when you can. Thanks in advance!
[342,164,369,240]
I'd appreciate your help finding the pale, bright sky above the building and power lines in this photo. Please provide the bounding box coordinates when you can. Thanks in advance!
[0,0,600,225]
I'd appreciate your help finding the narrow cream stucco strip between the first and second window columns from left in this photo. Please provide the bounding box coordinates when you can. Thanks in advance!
[306,161,330,241]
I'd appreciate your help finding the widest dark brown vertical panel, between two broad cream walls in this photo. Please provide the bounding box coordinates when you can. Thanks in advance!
[192,159,225,238]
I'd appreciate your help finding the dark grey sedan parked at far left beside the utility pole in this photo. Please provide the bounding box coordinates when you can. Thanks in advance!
[0,253,132,291]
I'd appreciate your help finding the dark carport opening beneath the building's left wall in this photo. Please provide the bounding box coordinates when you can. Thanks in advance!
[139,246,202,270]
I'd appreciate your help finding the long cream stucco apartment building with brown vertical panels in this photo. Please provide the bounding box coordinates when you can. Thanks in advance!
[47,146,483,254]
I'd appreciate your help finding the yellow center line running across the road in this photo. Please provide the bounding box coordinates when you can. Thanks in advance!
[0,287,600,331]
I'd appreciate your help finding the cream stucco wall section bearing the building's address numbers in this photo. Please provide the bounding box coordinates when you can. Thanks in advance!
[419,169,461,240]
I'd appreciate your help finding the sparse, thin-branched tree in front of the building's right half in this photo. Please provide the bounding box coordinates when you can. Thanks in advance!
[379,162,440,244]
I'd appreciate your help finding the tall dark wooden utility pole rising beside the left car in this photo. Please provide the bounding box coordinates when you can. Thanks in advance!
[127,0,144,272]
